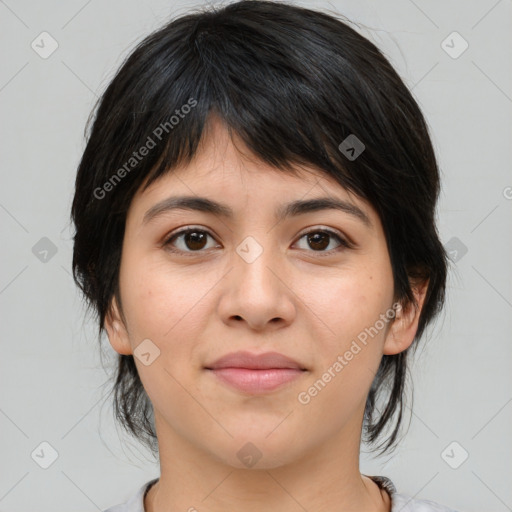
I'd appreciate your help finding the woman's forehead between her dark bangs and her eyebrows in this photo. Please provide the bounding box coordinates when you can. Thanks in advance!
[128,117,376,227]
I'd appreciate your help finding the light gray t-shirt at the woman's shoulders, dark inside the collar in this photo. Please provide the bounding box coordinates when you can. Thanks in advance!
[103,475,457,512]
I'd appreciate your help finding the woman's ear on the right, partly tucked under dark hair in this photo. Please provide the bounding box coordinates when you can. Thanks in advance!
[383,279,428,355]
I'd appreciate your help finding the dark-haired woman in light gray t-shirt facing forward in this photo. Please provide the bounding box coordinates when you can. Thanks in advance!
[72,1,458,512]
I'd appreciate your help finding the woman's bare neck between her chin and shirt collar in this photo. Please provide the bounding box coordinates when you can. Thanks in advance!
[144,415,391,512]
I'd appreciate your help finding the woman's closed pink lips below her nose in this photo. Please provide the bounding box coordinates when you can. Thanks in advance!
[206,351,305,393]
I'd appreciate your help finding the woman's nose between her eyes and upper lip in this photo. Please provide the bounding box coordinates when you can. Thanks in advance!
[219,237,297,331]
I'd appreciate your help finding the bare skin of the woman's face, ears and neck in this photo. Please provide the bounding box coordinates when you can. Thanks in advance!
[106,119,426,512]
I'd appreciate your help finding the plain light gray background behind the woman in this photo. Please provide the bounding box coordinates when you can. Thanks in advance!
[0,0,512,512]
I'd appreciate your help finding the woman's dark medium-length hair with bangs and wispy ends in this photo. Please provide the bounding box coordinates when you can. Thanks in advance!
[72,1,447,456]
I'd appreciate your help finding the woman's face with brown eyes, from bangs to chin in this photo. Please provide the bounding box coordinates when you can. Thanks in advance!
[106,118,421,468]
